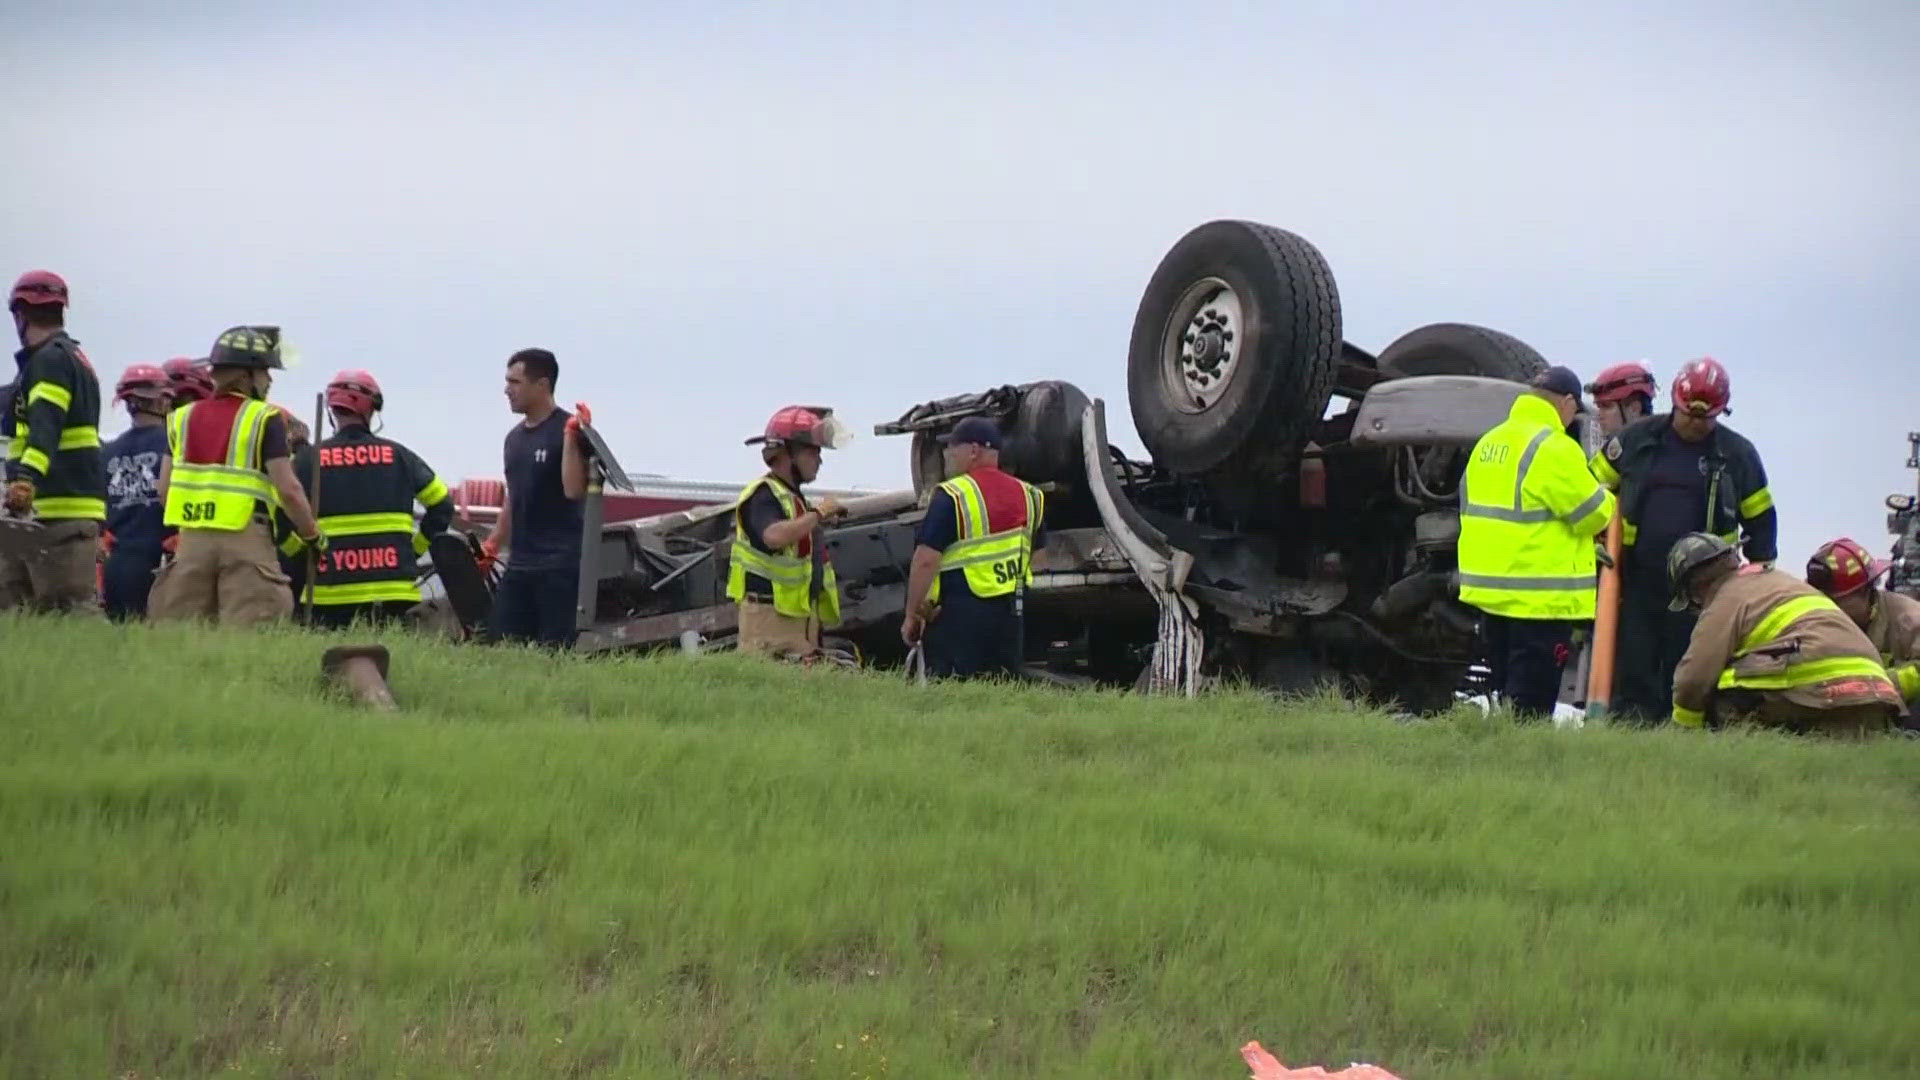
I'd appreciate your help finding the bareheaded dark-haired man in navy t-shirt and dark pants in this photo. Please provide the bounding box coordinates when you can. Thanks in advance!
[482,348,588,648]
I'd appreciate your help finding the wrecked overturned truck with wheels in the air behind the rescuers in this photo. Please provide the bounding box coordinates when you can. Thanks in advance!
[436,221,1546,711]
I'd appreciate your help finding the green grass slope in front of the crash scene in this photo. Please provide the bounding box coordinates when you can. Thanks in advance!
[0,619,1920,1080]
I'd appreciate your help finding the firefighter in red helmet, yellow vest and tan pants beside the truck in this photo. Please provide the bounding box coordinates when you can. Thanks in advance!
[726,405,847,659]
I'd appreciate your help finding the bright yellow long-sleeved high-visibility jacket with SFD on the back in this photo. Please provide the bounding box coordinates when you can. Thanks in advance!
[1459,394,1615,621]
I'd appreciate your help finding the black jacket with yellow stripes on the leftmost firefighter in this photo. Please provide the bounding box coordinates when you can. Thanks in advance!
[6,332,108,521]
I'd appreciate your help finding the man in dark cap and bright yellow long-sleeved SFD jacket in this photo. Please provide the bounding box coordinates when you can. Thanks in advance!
[1459,367,1615,719]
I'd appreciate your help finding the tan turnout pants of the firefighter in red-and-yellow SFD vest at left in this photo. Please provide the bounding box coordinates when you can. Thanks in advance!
[146,521,294,626]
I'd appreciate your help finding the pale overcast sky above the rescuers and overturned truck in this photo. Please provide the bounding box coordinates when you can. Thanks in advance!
[0,0,1920,569]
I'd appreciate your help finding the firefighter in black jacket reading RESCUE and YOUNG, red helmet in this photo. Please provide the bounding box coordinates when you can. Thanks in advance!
[294,371,453,628]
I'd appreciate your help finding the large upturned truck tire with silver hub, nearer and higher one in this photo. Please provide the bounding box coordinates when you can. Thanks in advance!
[1127,221,1340,480]
